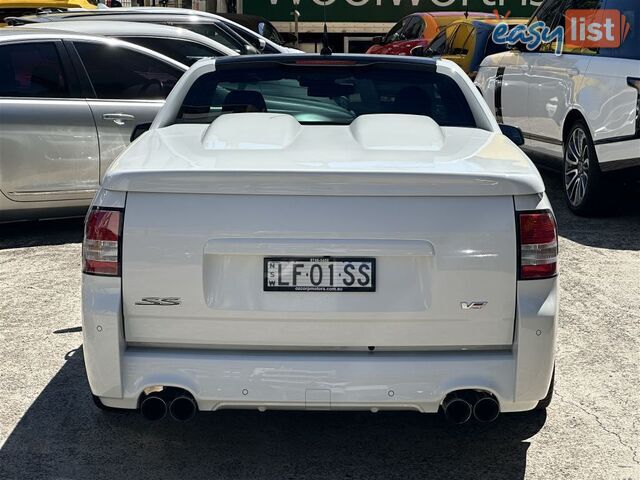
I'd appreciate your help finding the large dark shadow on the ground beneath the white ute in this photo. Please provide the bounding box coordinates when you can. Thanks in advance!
[0,348,546,480]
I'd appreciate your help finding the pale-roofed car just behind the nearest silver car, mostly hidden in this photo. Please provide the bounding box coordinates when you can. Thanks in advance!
[22,21,238,65]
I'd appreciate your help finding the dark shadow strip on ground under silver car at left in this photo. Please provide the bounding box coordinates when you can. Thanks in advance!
[0,218,84,250]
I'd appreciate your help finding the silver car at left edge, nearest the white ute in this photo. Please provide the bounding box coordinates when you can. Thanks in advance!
[0,28,187,222]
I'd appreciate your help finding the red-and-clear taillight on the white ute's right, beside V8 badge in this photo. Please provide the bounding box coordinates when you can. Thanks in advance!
[518,211,558,280]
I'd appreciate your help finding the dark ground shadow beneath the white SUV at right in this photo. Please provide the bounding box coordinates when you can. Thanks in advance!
[540,170,640,250]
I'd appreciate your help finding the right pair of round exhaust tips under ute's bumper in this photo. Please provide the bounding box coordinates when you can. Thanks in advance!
[442,390,500,425]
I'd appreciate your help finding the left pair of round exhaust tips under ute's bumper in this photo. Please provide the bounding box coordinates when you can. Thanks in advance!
[140,387,198,422]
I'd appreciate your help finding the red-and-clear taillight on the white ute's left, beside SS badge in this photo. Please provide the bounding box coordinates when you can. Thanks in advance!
[82,208,123,277]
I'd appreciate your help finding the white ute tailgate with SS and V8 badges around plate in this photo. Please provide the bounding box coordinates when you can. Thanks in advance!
[122,192,516,349]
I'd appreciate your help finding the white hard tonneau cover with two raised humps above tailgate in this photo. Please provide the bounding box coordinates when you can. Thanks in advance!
[103,113,544,197]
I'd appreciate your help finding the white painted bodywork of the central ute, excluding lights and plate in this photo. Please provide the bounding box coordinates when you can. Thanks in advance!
[83,57,557,412]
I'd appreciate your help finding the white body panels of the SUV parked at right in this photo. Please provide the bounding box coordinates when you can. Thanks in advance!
[475,50,640,171]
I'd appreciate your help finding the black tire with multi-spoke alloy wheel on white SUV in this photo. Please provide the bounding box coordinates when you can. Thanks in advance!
[562,120,606,216]
